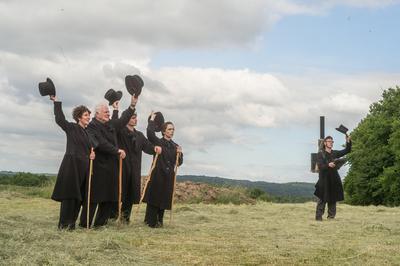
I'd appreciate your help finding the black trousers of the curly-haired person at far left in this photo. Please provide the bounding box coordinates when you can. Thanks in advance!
[58,199,81,230]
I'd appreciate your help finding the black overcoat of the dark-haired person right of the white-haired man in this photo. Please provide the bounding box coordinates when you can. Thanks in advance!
[113,111,154,204]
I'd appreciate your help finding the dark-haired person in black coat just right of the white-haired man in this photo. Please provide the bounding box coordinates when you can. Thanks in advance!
[112,109,161,223]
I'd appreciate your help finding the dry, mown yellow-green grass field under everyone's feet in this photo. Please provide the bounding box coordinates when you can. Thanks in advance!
[0,189,400,265]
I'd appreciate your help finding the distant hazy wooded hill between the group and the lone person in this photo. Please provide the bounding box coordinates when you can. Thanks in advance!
[177,175,315,198]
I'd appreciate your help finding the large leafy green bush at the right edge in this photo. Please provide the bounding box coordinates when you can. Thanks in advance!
[344,87,400,206]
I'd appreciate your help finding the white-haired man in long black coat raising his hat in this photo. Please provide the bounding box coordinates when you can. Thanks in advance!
[79,95,137,227]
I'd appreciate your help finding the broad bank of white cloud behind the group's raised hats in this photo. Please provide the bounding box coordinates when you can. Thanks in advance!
[0,56,398,175]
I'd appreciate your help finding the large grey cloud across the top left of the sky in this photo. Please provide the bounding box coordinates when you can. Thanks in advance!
[0,0,272,56]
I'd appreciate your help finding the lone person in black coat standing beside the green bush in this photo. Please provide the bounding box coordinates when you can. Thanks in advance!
[314,135,351,221]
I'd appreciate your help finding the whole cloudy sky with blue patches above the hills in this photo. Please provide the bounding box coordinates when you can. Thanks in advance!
[0,0,400,183]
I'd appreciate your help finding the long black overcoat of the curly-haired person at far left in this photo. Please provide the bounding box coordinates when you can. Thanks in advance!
[51,102,90,201]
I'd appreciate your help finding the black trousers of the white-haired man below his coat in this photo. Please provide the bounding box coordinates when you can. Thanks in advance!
[79,202,114,227]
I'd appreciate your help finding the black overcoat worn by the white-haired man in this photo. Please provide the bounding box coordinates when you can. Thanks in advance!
[88,108,135,203]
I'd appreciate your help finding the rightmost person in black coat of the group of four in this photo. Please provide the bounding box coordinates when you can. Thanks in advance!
[143,112,183,227]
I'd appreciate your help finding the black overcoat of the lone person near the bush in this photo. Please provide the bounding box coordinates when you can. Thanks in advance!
[314,142,351,203]
